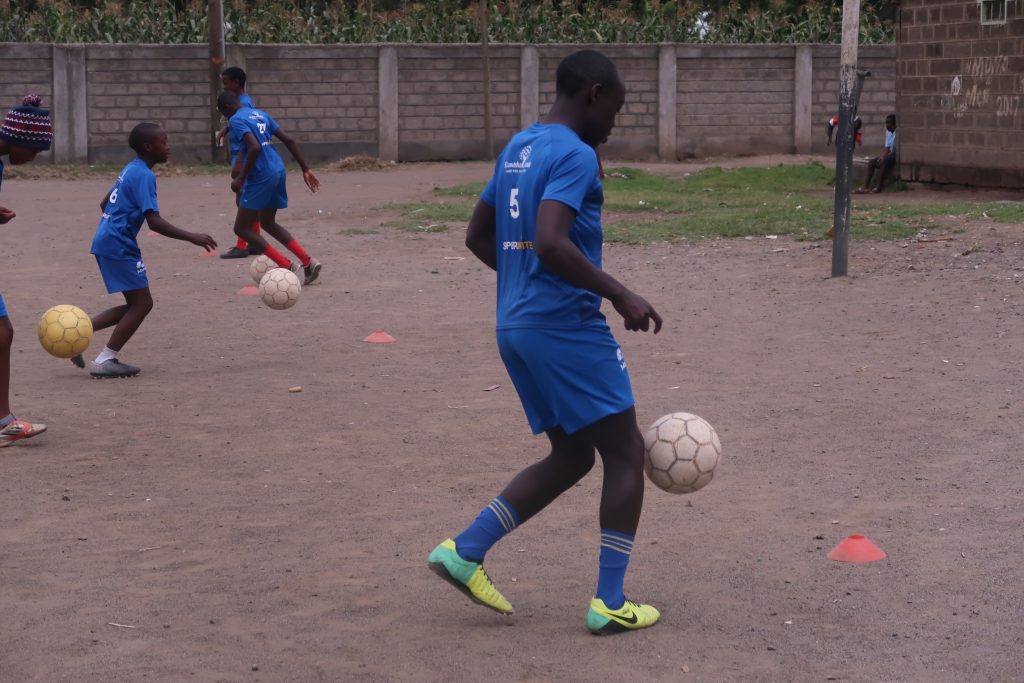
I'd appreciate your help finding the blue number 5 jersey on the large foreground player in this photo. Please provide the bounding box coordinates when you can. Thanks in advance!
[480,123,605,330]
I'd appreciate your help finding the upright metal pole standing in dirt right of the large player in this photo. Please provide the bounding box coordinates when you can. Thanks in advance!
[833,0,860,278]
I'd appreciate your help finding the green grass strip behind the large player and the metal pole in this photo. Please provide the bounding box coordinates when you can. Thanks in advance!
[390,163,1024,244]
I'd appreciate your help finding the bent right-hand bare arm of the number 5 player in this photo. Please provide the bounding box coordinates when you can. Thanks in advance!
[534,200,662,334]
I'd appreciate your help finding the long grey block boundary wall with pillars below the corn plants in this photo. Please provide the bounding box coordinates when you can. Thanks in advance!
[0,43,897,162]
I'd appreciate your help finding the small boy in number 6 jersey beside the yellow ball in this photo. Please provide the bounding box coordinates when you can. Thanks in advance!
[72,123,217,379]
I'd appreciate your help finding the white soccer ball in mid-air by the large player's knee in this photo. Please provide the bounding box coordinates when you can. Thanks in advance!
[643,413,722,494]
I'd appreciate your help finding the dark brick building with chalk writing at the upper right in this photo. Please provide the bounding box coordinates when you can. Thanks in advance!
[896,0,1024,187]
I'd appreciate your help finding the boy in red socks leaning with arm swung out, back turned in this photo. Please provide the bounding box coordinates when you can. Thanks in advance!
[217,90,321,285]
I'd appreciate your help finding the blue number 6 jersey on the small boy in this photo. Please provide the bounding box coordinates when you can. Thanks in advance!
[90,159,160,260]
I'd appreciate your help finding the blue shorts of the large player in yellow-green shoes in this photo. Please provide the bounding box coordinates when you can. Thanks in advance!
[498,326,634,434]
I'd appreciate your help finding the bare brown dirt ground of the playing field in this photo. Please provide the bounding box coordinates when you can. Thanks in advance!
[0,157,1024,683]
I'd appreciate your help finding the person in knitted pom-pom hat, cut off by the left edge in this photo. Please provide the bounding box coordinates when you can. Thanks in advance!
[0,95,53,449]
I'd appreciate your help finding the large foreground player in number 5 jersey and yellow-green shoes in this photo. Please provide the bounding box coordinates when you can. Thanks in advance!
[427,50,662,634]
